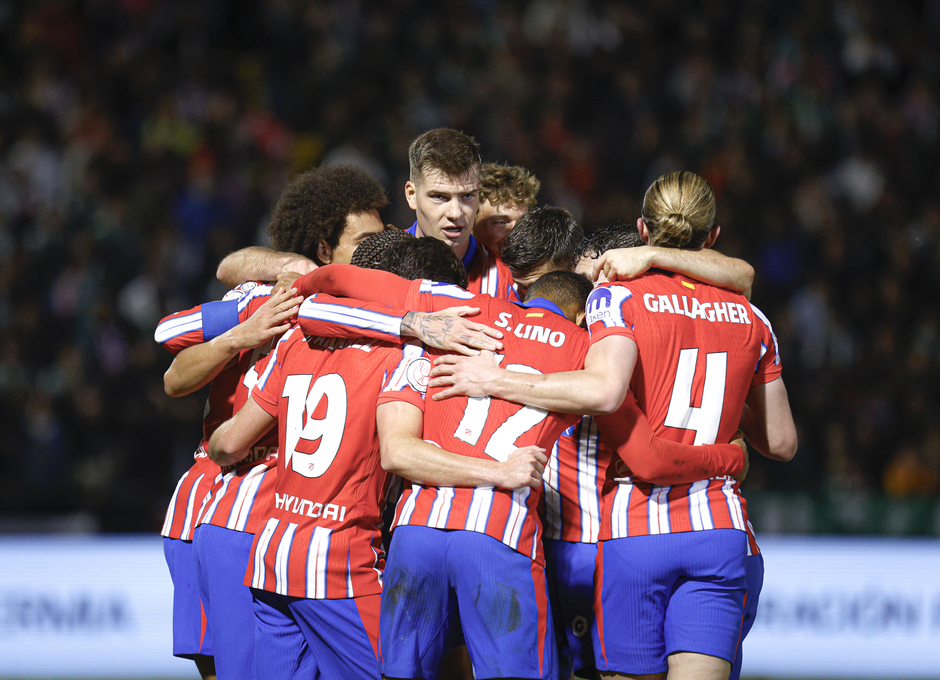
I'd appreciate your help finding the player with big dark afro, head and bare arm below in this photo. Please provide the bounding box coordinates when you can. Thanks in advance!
[216,165,388,287]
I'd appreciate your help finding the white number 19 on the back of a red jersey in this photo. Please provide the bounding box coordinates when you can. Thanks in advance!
[281,373,347,477]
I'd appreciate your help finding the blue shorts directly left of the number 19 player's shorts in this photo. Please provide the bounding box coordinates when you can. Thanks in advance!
[193,524,255,680]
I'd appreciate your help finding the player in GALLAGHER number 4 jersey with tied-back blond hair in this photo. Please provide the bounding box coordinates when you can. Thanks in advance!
[431,172,796,680]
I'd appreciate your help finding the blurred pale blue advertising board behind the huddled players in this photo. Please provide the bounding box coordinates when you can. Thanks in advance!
[0,536,940,679]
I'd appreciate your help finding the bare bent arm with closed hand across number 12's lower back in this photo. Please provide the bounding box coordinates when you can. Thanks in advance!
[376,401,548,489]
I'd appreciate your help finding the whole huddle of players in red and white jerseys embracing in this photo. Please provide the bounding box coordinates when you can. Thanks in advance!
[155,128,796,680]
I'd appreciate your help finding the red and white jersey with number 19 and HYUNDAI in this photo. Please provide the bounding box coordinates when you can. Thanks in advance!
[245,328,430,599]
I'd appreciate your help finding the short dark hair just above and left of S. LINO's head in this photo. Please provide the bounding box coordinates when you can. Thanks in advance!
[500,206,584,278]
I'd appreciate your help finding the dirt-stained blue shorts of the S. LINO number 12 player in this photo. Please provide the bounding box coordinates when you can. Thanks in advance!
[381,526,558,680]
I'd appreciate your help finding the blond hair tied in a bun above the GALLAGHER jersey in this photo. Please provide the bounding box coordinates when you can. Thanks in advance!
[643,170,716,249]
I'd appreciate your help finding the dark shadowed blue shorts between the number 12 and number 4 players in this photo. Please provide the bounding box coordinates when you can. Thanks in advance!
[543,539,597,678]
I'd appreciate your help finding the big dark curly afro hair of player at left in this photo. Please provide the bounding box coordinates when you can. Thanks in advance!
[268,165,388,264]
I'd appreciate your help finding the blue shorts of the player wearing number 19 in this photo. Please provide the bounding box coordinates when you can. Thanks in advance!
[251,588,381,680]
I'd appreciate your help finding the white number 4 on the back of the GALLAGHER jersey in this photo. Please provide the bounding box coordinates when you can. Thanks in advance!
[663,348,728,446]
